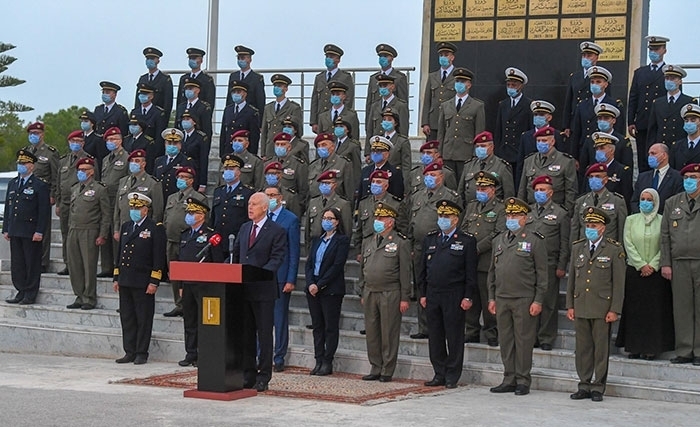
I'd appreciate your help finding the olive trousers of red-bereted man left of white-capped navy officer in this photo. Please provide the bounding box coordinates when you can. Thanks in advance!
[66,228,100,305]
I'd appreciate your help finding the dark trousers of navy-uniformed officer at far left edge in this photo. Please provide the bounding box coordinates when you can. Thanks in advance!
[10,236,43,301]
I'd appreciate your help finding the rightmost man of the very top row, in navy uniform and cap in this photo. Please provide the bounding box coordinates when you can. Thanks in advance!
[628,36,670,172]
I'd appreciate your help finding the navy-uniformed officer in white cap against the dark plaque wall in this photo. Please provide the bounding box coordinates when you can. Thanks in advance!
[493,67,532,184]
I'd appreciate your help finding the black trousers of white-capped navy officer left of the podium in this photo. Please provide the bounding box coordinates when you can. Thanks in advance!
[119,286,156,357]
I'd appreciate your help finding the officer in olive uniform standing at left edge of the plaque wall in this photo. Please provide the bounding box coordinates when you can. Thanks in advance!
[420,42,460,140]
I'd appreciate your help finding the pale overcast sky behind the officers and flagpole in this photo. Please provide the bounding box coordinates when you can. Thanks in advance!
[0,0,700,130]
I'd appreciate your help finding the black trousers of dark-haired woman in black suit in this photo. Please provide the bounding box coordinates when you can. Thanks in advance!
[306,293,343,363]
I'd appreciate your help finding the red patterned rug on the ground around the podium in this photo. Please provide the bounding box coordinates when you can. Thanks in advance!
[112,366,455,405]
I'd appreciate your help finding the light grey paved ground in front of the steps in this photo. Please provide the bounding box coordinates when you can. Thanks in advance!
[0,353,700,427]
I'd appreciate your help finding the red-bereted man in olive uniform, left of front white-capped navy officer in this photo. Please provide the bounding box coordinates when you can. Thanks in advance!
[66,157,112,310]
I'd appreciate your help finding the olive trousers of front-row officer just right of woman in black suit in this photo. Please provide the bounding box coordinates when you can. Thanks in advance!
[363,288,401,377]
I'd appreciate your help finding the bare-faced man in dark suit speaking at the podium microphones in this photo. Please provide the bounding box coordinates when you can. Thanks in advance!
[233,193,288,392]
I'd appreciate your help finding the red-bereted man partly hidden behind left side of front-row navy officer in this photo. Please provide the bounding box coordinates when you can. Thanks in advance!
[408,161,462,339]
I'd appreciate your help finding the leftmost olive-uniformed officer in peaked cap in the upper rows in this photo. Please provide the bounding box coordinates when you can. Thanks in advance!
[259,74,300,161]
